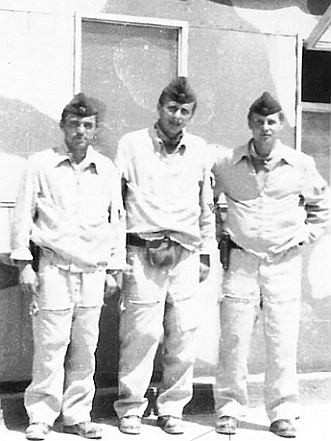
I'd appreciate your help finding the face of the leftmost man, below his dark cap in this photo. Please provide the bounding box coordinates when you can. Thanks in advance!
[61,113,97,163]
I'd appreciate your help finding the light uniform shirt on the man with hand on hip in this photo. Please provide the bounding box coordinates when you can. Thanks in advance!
[212,140,330,257]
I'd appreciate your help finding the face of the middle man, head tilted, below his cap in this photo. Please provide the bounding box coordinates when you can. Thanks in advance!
[157,97,195,139]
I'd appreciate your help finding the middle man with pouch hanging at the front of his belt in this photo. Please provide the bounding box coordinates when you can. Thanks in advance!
[115,77,215,434]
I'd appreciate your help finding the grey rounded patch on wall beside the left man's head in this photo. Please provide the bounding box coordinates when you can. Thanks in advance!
[0,97,63,157]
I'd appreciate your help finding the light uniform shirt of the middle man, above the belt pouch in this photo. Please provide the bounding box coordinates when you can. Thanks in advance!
[116,125,215,254]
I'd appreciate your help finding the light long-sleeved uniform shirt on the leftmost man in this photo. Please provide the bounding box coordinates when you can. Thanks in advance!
[11,145,125,272]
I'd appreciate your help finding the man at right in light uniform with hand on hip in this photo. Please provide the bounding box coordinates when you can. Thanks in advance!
[213,92,329,438]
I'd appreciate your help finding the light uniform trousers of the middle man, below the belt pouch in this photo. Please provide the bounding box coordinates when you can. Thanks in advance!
[114,246,201,418]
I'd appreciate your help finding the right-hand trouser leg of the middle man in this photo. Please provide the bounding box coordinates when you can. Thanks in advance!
[156,249,203,418]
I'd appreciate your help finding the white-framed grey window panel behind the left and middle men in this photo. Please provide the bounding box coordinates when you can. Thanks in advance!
[75,14,187,157]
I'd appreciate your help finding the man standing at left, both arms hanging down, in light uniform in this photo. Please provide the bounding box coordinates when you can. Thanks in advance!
[11,93,125,440]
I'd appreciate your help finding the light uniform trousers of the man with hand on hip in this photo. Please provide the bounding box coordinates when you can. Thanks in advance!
[214,246,302,422]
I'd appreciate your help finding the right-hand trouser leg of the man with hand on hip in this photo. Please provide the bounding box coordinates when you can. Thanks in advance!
[261,248,302,421]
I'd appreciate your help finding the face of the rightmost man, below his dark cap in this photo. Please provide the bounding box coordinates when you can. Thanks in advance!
[249,112,283,156]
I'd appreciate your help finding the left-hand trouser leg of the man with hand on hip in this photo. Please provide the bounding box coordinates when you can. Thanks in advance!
[214,249,260,419]
